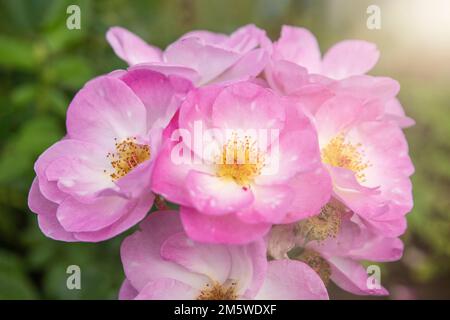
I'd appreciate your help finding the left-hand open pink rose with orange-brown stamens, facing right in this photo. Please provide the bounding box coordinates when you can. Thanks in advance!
[28,69,191,242]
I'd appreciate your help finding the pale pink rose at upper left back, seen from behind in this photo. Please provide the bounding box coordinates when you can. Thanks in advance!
[106,25,271,86]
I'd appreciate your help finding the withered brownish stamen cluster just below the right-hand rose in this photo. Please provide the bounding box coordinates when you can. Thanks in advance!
[295,200,345,242]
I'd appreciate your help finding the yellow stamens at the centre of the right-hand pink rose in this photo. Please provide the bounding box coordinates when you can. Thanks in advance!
[322,133,370,182]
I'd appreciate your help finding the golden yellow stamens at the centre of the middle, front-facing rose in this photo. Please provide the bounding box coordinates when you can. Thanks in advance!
[215,135,264,187]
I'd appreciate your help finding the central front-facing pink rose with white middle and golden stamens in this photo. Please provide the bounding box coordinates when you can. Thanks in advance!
[152,82,331,243]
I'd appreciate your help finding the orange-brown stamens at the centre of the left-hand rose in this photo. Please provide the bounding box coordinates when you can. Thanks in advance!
[105,138,150,181]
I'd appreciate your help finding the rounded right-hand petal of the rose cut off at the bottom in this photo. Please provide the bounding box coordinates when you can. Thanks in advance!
[256,259,328,300]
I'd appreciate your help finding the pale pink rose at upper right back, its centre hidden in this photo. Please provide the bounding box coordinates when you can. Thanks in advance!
[265,26,414,127]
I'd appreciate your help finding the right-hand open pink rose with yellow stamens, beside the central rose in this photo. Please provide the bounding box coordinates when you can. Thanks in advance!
[314,96,414,237]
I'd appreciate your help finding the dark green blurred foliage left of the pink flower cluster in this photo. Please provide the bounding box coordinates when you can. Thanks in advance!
[0,0,130,299]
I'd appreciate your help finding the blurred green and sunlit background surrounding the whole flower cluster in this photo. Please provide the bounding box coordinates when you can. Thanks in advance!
[0,0,450,299]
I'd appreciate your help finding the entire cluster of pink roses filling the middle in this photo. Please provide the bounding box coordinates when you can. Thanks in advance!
[29,25,414,300]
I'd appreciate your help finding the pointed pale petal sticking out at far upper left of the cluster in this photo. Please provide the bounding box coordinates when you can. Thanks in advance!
[106,27,162,65]
